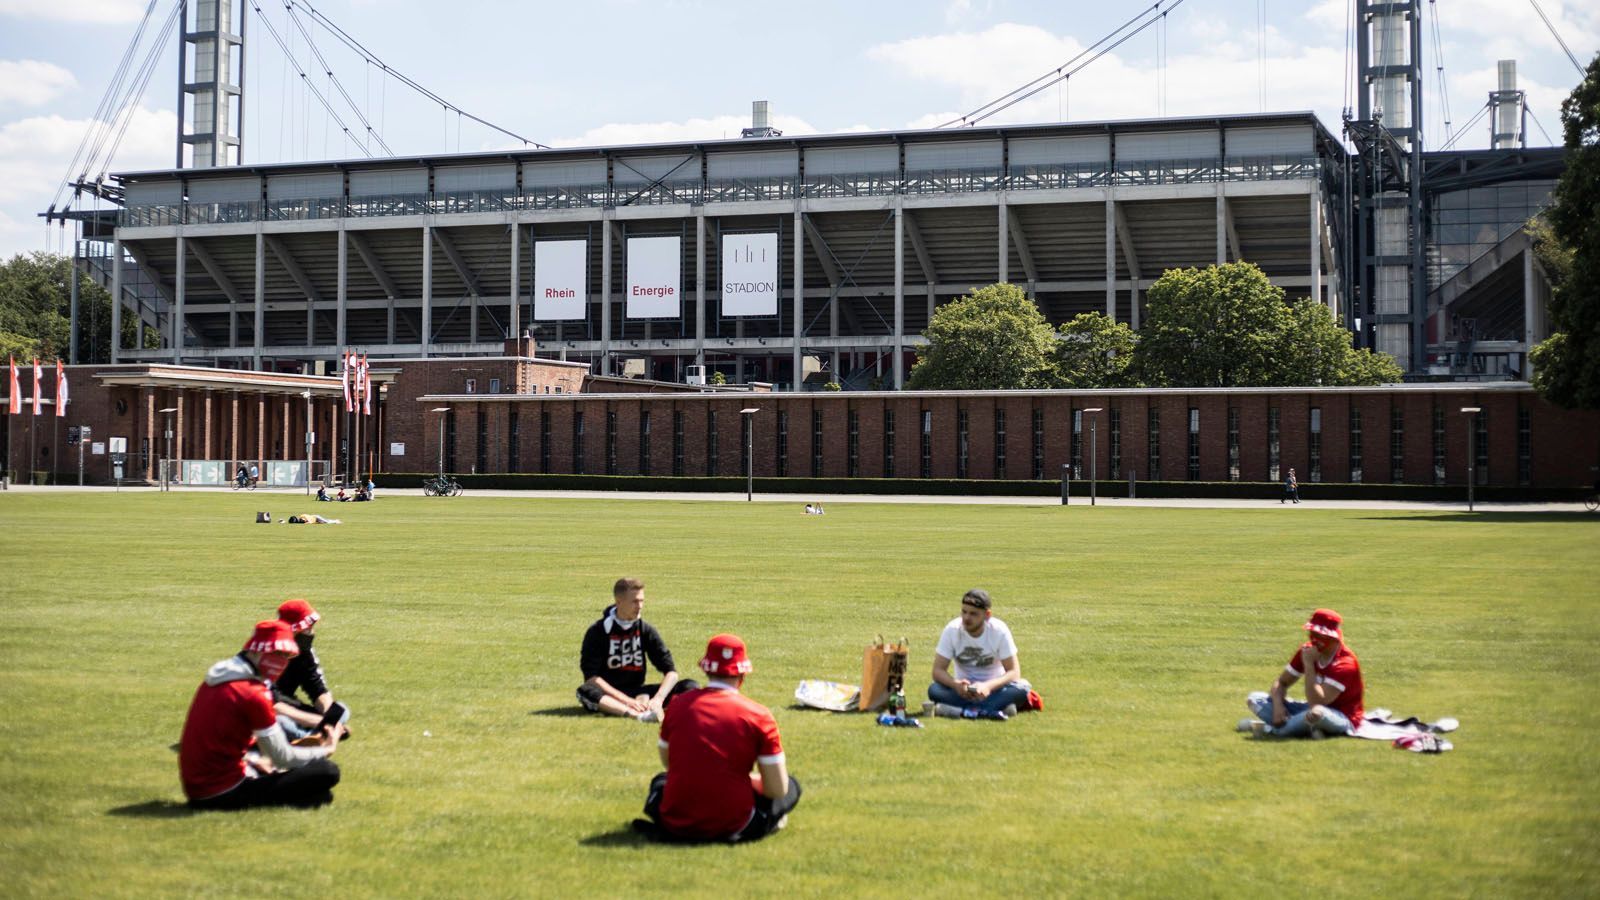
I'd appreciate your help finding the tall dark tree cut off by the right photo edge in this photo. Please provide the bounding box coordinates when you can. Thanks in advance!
[1530,54,1600,408]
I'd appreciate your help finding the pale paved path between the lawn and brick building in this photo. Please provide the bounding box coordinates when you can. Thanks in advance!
[0,485,1600,520]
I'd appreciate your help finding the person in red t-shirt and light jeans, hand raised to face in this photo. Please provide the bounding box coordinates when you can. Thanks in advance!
[1238,610,1365,738]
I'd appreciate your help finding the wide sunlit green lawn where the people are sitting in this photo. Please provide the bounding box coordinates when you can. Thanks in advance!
[0,493,1600,897]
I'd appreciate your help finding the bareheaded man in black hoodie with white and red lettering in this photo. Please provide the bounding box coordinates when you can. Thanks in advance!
[578,578,699,722]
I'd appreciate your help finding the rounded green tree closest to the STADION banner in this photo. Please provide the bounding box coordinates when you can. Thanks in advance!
[909,283,1056,391]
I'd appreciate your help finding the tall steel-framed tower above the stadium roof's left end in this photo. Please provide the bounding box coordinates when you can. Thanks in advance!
[178,0,245,168]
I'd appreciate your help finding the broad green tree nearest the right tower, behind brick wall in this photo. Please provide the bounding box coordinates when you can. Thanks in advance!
[1134,263,1402,388]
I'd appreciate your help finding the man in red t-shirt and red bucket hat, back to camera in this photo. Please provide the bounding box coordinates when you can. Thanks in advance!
[634,634,800,842]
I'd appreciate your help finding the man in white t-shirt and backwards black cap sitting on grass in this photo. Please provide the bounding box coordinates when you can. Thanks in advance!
[928,588,1032,719]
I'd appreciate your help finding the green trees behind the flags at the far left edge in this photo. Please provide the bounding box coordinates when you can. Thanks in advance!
[0,253,149,362]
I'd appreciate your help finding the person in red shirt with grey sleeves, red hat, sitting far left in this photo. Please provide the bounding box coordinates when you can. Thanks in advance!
[178,618,339,809]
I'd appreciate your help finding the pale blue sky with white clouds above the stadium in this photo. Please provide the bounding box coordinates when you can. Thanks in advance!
[0,0,1600,259]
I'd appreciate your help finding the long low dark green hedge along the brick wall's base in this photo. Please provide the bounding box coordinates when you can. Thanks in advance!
[374,472,1587,503]
